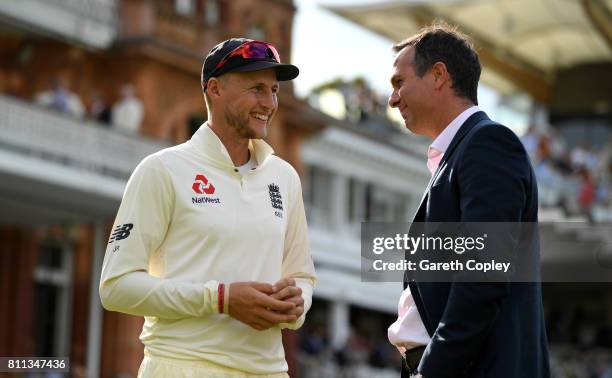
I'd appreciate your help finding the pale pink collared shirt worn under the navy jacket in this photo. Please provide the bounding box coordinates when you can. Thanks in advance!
[387,106,480,354]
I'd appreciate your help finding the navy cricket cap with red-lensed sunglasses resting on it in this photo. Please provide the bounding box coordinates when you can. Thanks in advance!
[200,38,300,91]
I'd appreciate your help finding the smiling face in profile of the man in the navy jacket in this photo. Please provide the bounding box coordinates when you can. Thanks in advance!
[389,46,436,136]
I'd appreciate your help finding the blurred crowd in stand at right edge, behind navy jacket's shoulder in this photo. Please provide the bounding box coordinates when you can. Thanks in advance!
[522,128,612,221]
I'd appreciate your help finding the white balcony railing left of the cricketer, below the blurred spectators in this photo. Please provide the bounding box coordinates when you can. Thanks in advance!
[0,95,167,180]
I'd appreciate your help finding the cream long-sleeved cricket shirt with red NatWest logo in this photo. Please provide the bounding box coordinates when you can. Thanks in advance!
[100,124,315,374]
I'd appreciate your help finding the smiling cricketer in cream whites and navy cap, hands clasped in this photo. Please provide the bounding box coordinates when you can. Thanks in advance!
[100,38,315,377]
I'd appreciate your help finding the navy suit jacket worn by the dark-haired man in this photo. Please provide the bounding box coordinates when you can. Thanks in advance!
[402,112,550,378]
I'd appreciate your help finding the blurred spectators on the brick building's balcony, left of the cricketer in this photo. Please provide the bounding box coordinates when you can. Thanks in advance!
[29,78,144,134]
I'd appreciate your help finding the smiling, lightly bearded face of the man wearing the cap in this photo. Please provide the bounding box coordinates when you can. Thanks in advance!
[219,69,279,139]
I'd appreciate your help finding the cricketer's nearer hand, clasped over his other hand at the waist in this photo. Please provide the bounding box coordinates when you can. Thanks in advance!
[229,281,304,331]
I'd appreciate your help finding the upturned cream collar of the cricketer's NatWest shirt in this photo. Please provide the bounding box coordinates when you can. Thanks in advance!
[190,122,274,168]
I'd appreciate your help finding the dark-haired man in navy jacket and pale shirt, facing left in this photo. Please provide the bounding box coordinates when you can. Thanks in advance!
[388,25,550,378]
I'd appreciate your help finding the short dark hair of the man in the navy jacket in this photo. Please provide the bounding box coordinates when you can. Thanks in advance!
[393,23,481,105]
